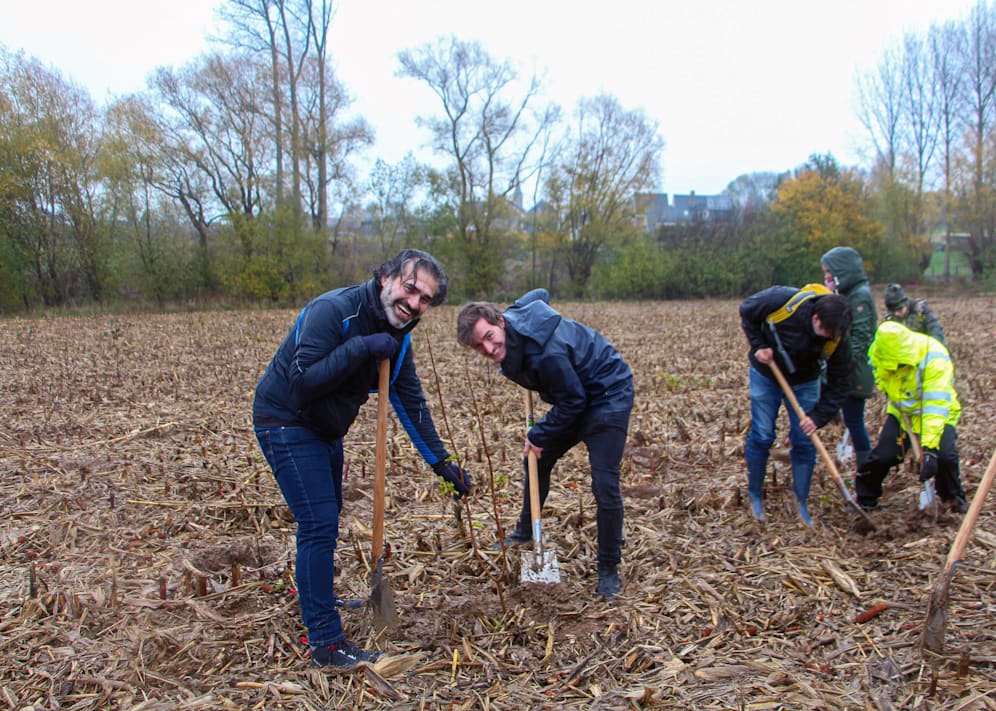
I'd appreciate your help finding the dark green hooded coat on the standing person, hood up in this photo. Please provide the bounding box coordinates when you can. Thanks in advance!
[820,247,878,398]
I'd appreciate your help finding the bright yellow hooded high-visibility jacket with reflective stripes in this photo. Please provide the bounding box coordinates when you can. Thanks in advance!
[868,321,961,449]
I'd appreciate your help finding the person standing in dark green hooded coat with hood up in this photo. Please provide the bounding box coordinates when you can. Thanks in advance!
[820,247,878,467]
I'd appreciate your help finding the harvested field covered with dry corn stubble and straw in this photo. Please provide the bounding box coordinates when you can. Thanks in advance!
[0,297,996,710]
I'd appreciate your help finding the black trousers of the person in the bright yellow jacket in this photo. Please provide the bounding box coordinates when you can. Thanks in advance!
[854,415,965,506]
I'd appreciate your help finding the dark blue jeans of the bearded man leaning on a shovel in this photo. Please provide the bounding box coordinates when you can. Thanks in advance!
[255,427,345,647]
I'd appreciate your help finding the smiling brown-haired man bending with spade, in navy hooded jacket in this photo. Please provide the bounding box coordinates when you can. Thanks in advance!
[457,289,633,600]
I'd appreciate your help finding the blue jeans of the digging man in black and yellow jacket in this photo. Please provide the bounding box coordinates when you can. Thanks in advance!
[744,368,820,503]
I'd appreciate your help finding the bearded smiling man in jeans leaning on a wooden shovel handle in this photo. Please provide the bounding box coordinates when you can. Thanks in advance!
[253,249,471,669]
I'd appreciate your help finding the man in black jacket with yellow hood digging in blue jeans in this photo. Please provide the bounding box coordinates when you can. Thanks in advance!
[740,286,851,526]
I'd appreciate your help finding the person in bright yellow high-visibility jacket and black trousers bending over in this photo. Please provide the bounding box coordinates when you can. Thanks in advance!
[855,321,968,513]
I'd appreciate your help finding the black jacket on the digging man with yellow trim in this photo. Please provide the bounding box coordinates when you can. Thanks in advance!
[740,286,851,427]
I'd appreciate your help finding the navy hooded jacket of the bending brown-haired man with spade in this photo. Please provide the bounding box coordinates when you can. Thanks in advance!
[501,289,633,448]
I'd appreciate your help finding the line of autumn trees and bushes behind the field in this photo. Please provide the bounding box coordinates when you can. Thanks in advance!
[0,0,996,312]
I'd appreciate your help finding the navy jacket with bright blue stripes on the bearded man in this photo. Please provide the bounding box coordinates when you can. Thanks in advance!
[253,279,448,466]
